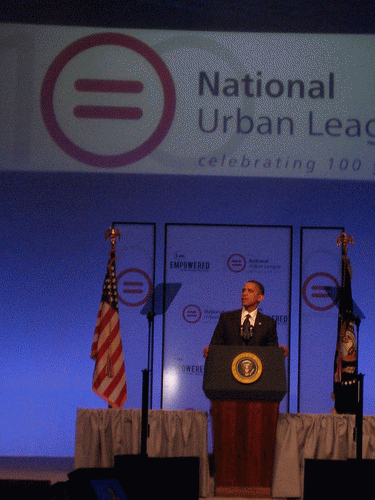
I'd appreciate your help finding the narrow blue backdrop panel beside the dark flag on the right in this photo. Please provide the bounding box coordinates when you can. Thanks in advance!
[298,227,343,413]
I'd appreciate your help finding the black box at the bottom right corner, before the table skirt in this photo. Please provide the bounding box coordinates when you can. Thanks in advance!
[304,459,375,500]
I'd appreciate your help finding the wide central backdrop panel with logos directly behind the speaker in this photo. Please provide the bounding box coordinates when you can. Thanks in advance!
[162,224,292,410]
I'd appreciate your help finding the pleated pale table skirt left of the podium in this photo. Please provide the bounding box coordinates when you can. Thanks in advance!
[74,409,209,497]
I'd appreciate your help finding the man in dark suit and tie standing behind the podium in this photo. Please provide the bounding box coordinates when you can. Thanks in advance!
[204,280,287,357]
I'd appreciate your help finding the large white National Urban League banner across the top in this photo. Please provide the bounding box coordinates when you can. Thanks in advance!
[0,24,375,180]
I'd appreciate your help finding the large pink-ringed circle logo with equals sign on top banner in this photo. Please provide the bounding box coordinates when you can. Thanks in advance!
[41,33,176,168]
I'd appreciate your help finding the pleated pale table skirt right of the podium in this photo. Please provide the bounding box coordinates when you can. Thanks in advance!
[272,414,375,498]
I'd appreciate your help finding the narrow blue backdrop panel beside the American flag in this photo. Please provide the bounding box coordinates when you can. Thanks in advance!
[115,222,155,408]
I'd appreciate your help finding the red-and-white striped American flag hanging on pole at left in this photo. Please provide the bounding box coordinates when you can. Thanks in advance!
[91,249,127,408]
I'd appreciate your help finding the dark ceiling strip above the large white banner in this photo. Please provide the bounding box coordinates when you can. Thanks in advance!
[0,0,375,34]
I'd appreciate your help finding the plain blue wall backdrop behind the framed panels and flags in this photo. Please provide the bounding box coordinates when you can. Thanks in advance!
[0,172,375,456]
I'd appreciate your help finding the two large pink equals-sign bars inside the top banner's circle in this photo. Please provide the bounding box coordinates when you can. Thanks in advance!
[74,78,143,120]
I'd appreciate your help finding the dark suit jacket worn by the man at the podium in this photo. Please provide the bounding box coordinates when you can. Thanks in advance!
[211,309,279,346]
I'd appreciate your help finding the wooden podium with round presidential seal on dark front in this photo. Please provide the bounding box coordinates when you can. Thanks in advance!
[203,345,286,498]
